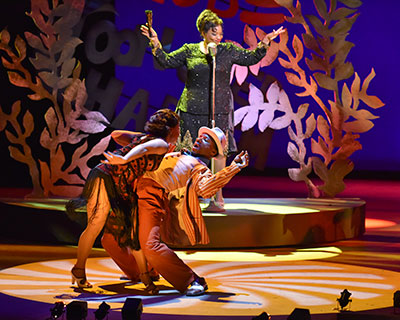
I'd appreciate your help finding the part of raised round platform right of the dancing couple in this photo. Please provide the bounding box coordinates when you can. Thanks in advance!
[199,198,365,248]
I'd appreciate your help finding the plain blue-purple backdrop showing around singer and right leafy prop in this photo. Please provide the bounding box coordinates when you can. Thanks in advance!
[115,0,400,171]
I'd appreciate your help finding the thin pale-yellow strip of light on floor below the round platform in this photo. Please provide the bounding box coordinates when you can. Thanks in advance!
[177,247,342,262]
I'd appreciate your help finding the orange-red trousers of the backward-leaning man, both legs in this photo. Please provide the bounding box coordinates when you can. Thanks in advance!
[102,178,198,293]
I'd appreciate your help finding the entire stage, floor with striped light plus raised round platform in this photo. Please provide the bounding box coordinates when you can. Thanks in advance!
[0,176,400,320]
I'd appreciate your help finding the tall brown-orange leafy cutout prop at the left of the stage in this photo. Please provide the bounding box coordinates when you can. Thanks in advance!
[0,0,110,197]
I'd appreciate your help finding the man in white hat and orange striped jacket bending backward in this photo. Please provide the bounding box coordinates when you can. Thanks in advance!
[102,127,249,296]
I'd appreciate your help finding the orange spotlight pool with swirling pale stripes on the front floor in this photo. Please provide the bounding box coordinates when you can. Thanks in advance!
[0,258,398,319]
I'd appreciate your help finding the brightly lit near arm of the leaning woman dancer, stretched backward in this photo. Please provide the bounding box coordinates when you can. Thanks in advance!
[101,139,168,165]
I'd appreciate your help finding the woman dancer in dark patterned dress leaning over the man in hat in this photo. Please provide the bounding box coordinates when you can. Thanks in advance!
[66,109,179,291]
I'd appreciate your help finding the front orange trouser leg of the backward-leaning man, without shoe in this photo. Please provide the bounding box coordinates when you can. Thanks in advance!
[138,179,198,293]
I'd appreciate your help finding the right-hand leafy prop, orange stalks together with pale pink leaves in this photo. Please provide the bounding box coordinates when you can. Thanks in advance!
[233,0,384,197]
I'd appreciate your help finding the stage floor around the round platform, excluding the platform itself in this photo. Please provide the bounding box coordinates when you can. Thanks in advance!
[0,176,400,320]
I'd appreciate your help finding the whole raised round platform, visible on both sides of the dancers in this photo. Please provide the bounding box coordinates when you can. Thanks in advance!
[0,198,365,249]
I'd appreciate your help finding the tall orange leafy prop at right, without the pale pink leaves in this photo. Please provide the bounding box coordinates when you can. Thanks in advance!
[276,0,384,197]
